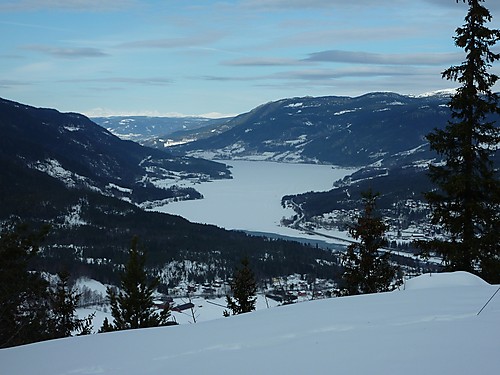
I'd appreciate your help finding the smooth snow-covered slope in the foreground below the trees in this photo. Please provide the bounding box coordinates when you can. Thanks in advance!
[0,272,500,375]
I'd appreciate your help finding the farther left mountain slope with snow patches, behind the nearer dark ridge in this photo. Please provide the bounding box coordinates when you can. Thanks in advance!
[0,99,230,203]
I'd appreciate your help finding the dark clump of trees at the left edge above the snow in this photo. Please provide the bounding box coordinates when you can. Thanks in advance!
[0,224,92,348]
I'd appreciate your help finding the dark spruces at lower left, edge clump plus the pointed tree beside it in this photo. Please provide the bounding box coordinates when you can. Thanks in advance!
[0,223,171,348]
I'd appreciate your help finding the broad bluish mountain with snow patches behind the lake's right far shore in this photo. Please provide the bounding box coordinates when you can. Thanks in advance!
[175,93,456,166]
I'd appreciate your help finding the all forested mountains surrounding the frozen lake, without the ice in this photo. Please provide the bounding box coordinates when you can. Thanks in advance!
[0,93,500,282]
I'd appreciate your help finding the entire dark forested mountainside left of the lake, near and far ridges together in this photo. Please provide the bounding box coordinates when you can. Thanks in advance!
[0,99,342,286]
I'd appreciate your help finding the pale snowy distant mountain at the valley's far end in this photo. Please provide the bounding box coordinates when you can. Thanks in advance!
[92,116,230,147]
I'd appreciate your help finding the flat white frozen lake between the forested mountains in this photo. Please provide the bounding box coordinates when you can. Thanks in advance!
[155,161,354,242]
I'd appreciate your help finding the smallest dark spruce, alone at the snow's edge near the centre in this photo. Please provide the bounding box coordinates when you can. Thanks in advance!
[224,257,257,316]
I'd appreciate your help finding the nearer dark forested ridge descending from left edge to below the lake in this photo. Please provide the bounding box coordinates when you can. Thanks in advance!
[0,149,335,285]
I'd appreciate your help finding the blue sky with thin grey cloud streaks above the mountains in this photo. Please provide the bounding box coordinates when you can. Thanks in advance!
[0,0,500,116]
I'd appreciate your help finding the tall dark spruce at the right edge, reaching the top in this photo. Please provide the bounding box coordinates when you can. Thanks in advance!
[420,0,500,282]
